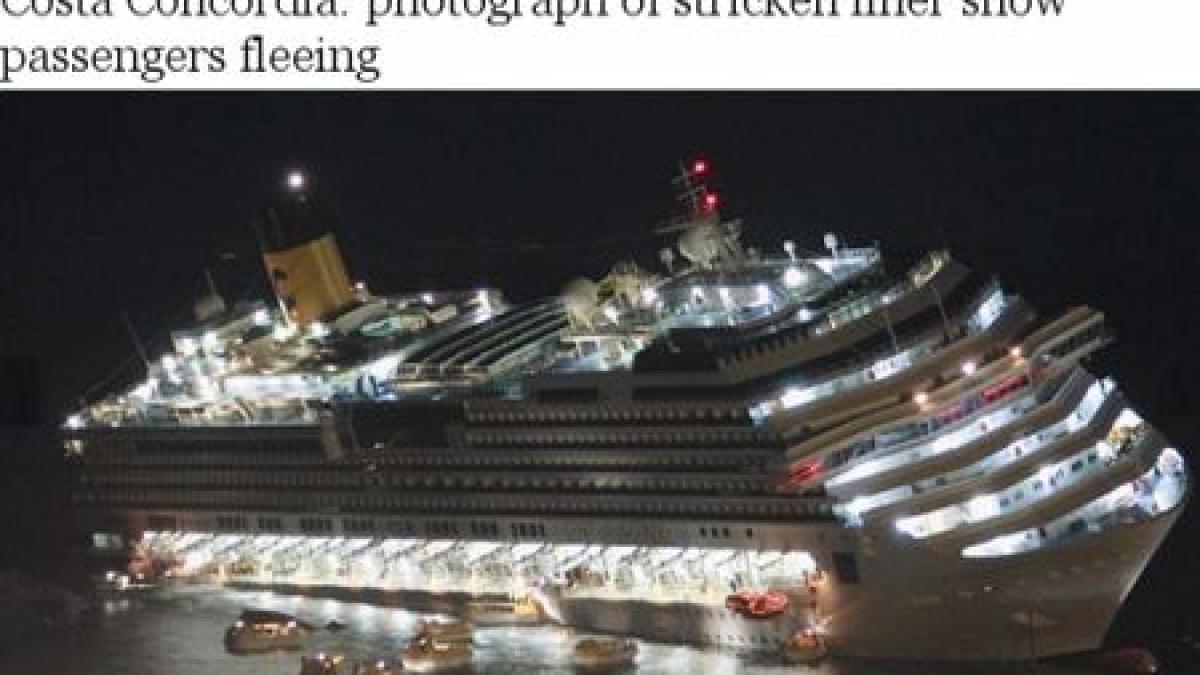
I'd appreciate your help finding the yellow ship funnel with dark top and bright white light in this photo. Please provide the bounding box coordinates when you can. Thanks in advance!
[254,172,354,329]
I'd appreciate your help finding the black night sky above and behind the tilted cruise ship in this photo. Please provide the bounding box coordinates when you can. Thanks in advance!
[0,92,1200,653]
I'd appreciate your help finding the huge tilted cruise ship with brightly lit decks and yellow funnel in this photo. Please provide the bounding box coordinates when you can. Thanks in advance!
[62,160,1189,659]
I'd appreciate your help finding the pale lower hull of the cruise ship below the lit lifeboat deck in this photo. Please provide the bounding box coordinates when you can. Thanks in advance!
[126,503,1182,661]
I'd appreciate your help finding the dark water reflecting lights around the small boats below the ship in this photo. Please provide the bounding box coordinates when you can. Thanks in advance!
[0,587,1132,675]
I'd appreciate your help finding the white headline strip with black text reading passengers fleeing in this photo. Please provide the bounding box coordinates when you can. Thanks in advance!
[0,0,1200,89]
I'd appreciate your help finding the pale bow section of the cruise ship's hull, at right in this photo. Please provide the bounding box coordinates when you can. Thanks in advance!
[829,507,1182,661]
